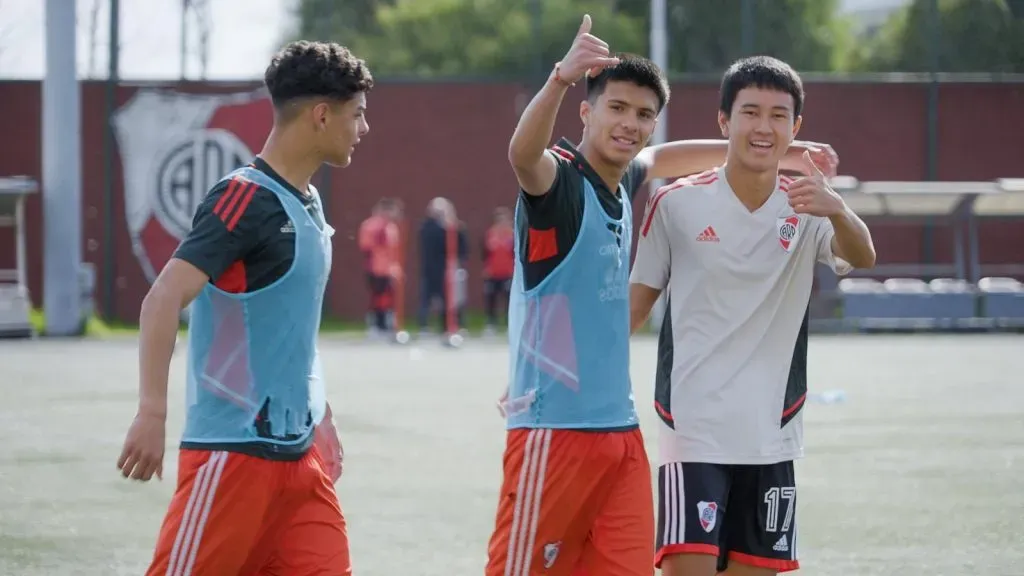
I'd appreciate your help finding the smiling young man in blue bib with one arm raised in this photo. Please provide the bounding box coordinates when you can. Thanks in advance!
[486,12,839,576]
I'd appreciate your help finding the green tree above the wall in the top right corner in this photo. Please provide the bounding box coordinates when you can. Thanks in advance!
[854,0,1024,73]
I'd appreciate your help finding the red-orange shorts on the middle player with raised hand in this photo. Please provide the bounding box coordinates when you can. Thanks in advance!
[485,428,654,576]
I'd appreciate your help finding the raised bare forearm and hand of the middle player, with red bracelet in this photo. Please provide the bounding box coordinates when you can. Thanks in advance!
[509,14,618,196]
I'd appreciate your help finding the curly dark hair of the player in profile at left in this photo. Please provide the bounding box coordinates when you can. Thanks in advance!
[263,40,374,109]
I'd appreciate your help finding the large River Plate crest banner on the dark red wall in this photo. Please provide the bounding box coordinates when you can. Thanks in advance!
[113,89,271,283]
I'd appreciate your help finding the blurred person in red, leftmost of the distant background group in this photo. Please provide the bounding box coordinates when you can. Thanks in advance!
[359,198,398,337]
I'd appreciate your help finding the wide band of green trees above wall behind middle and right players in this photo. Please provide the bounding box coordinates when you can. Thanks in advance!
[288,0,850,78]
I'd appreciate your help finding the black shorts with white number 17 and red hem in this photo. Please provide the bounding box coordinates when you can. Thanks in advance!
[654,461,800,572]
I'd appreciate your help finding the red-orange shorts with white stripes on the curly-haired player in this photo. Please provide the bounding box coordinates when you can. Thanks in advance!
[146,448,352,576]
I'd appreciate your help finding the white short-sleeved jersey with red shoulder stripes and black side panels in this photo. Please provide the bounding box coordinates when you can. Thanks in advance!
[631,168,850,464]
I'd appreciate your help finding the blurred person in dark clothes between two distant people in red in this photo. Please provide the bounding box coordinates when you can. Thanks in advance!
[418,197,469,334]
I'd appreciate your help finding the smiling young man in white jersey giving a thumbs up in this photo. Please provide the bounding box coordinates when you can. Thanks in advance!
[630,56,874,576]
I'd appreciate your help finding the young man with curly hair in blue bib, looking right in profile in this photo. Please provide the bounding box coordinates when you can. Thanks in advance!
[118,41,373,576]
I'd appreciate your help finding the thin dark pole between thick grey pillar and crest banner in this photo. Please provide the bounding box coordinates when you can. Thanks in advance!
[102,0,121,321]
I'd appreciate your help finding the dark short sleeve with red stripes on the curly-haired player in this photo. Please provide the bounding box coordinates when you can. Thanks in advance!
[173,180,281,282]
